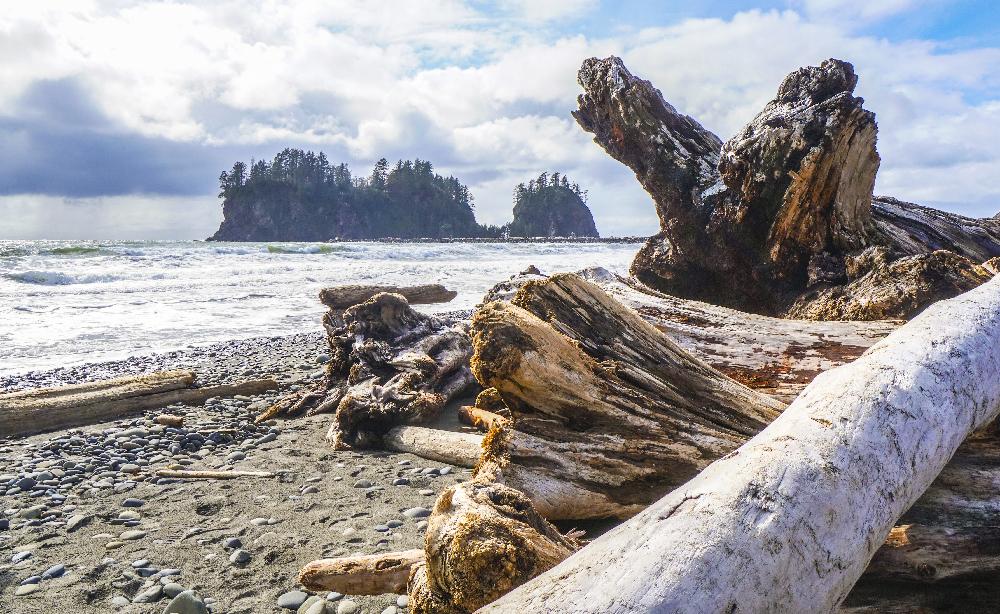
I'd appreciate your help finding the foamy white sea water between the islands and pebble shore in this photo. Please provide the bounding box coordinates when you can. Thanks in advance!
[0,241,639,375]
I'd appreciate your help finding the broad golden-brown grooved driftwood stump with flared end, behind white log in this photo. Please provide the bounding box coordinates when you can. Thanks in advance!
[472,275,784,519]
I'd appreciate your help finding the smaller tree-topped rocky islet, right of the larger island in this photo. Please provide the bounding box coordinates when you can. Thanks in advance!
[508,185,600,237]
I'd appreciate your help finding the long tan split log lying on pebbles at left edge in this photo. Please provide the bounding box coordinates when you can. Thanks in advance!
[0,371,278,435]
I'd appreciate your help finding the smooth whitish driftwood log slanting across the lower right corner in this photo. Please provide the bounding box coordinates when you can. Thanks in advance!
[482,279,1000,613]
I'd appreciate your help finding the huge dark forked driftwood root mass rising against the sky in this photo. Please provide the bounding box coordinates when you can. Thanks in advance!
[574,57,1000,319]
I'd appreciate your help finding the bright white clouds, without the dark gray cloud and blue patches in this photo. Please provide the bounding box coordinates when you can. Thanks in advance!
[0,0,1000,234]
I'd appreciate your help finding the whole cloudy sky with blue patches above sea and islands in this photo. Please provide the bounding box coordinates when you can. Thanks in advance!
[0,0,1000,239]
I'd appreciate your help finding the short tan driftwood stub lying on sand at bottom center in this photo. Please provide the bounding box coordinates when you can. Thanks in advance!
[299,550,424,595]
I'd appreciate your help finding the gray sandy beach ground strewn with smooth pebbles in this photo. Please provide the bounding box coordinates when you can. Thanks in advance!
[0,334,469,614]
